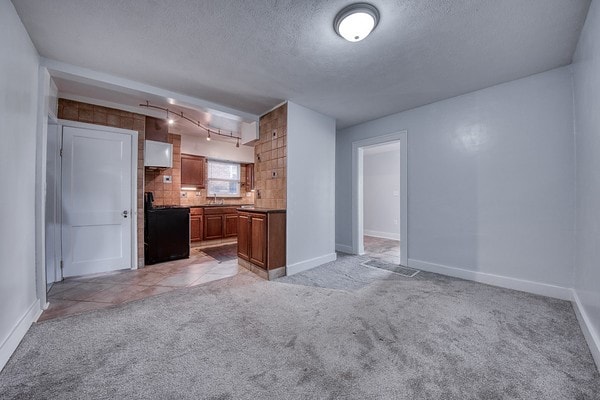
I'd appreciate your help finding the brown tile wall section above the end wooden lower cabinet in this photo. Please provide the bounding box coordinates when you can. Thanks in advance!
[254,103,287,209]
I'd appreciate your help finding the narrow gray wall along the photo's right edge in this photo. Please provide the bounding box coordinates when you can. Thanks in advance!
[573,1,600,365]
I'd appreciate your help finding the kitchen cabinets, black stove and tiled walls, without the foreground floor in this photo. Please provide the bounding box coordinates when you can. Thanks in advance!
[144,101,287,279]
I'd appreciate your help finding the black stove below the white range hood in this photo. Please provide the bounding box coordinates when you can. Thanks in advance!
[144,192,190,265]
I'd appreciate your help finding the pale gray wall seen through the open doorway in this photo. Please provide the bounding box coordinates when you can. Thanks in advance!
[363,147,400,240]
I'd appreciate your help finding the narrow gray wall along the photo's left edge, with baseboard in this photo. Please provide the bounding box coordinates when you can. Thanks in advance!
[0,1,39,368]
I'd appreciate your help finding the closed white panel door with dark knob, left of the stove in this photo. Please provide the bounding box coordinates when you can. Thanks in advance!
[62,126,133,277]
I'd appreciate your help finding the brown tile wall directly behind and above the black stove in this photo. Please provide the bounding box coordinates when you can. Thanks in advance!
[145,133,181,206]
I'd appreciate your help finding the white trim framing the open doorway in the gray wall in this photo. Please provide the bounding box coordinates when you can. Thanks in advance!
[352,130,408,265]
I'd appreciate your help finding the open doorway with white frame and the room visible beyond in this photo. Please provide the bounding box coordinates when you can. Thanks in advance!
[352,131,408,266]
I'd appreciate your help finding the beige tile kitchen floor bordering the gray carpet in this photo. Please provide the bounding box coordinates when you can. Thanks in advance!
[39,244,238,321]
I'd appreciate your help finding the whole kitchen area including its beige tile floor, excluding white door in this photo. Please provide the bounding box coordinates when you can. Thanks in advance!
[42,99,287,319]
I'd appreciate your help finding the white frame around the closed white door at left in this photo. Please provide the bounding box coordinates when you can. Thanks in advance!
[56,119,138,280]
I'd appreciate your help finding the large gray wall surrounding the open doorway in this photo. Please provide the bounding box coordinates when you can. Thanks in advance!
[336,67,575,292]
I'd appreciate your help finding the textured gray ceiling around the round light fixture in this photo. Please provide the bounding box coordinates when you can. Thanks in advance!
[13,0,589,127]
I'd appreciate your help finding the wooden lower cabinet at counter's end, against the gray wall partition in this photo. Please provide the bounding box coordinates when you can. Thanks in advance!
[238,210,285,270]
